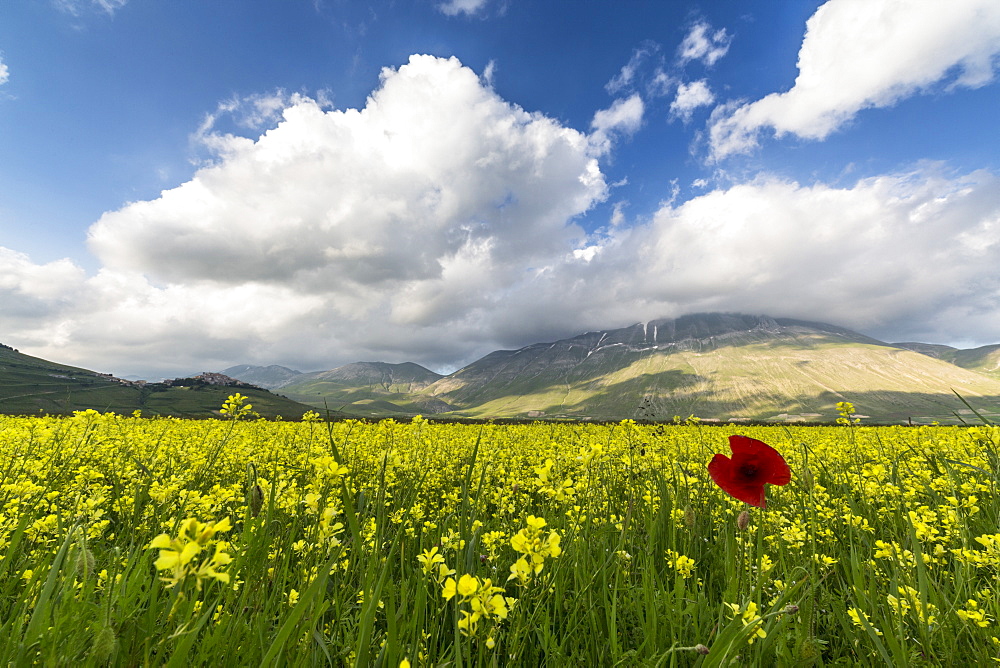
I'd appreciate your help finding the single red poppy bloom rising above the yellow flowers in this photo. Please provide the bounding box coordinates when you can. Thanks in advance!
[708,436,792,508]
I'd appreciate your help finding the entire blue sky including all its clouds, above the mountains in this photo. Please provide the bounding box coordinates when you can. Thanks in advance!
[0,0,1000,377]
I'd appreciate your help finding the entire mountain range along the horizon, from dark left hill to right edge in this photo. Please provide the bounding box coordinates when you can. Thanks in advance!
[13,313,1000,422]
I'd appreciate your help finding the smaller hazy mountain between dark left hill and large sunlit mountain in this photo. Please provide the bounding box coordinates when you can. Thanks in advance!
[264,362,452,416]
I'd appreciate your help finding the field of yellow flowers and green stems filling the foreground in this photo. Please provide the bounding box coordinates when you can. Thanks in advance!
[0,399,1000,668]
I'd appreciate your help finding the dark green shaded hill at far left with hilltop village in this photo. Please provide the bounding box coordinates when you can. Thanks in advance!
[0,344,310,418]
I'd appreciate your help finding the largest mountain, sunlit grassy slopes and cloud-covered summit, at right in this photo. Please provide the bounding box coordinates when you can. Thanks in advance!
[422,313,1000,422]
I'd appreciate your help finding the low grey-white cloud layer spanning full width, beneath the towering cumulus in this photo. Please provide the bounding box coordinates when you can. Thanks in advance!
[7,165,1000,373]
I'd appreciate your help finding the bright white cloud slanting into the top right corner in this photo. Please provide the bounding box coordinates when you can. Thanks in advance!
[710,0,1000,160]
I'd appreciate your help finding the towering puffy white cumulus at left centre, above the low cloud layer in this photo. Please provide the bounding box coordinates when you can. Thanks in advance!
[89,56,600,291]
